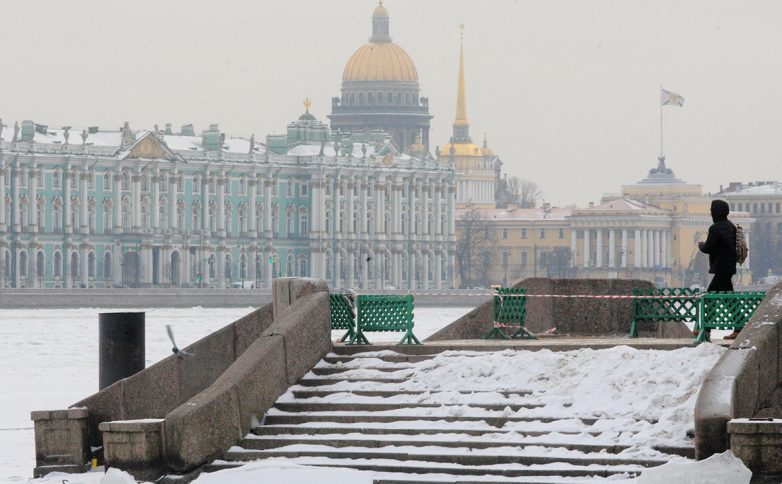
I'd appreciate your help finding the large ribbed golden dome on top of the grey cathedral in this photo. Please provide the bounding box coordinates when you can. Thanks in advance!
[342,43,418,81]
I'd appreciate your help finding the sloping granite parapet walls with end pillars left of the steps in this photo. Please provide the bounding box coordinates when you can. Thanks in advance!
[31,278,331,479]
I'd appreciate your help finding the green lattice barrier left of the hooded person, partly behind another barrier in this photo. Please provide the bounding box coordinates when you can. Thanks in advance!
[629,287,700,338]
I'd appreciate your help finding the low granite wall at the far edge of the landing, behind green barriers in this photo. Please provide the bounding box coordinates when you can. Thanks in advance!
[426,277,692,341]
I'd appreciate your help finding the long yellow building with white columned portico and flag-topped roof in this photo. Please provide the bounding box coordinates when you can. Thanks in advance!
[456,161,758,287]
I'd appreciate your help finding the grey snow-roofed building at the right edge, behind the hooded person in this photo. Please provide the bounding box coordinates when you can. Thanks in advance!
[715,181,782,282]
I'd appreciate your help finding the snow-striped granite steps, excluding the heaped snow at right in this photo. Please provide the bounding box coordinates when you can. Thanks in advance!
[205,347,693,484]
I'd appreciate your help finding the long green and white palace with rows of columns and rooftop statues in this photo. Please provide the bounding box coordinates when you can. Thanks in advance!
[0,110,456,289]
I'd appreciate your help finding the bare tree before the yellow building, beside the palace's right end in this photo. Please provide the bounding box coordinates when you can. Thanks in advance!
[456,208,496,287]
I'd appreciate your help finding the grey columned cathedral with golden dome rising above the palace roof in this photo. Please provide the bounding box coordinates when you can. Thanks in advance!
[328,2,433,153]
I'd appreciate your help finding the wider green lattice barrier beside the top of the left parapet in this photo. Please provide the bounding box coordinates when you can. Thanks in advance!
[348,294,421,345]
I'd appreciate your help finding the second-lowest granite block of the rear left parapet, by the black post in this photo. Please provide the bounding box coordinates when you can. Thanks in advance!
[124,356,180,422]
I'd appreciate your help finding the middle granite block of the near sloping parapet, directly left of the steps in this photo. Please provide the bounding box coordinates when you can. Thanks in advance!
[221,335,288,435]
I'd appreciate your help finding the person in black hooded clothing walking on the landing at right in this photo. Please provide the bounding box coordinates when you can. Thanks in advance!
[698,200,739,339]
